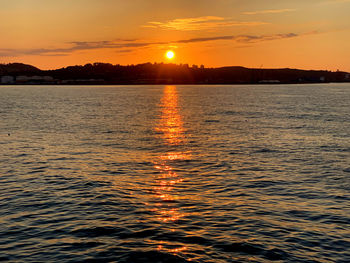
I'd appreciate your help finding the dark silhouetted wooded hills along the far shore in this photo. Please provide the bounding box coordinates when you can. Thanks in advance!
[0,63,350,84]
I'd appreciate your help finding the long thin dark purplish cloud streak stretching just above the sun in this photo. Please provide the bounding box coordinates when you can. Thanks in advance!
[0,31,318,57]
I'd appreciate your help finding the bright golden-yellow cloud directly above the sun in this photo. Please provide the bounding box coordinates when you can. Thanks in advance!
[143,16,268,31]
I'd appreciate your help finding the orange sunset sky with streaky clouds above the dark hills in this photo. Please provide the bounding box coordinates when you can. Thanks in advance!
[0,0,350,71]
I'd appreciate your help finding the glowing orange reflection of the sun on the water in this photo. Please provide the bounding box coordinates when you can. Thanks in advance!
[154,86,191,253]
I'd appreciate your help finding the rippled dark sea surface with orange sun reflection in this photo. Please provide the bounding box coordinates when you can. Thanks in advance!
[0,84,350,263]
